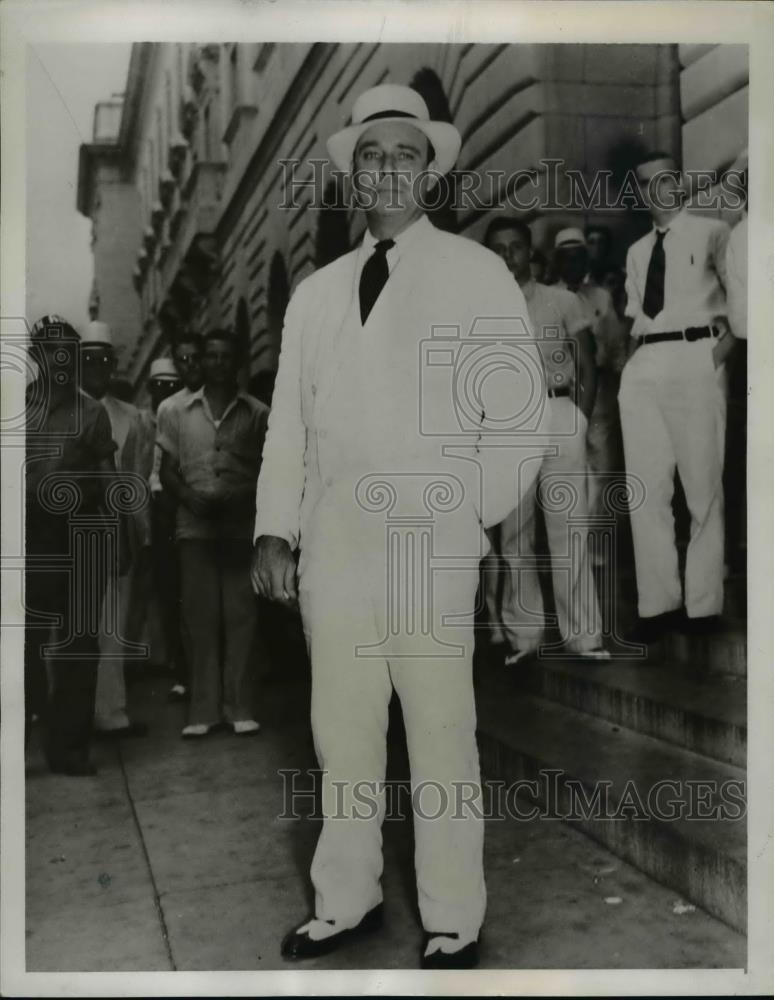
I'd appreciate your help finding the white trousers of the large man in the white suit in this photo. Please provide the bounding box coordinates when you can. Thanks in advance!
[300,500,486,942]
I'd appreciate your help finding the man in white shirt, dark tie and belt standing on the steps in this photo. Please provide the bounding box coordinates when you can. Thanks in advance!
[619,153,734,643]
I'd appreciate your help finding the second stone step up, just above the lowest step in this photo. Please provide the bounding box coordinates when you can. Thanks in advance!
[514,659,747,768]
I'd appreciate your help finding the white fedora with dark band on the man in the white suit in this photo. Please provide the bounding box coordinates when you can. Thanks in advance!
[327,83,462,174]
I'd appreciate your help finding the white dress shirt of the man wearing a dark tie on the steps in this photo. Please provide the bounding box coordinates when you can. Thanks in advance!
[626,209,730,337]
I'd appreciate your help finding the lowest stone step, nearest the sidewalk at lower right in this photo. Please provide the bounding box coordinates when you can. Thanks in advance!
[476,667,747,932]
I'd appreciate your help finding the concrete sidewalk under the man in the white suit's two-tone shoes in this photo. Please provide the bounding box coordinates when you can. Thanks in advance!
[27,678,746,971]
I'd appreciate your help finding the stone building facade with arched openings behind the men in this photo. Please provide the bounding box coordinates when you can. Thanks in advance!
[79,42,747,387]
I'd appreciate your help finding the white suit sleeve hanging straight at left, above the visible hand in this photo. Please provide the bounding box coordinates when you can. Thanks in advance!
[253,283,306,548]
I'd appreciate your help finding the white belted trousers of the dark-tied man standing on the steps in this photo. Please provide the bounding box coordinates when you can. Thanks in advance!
[619,338,726,618]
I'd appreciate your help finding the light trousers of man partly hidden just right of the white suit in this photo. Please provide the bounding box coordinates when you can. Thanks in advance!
[484,397,602,653]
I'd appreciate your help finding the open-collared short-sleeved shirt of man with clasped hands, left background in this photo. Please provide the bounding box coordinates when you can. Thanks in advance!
[156,389,269,539]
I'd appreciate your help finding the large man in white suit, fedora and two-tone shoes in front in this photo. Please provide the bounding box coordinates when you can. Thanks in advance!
[252,84,548,968]
